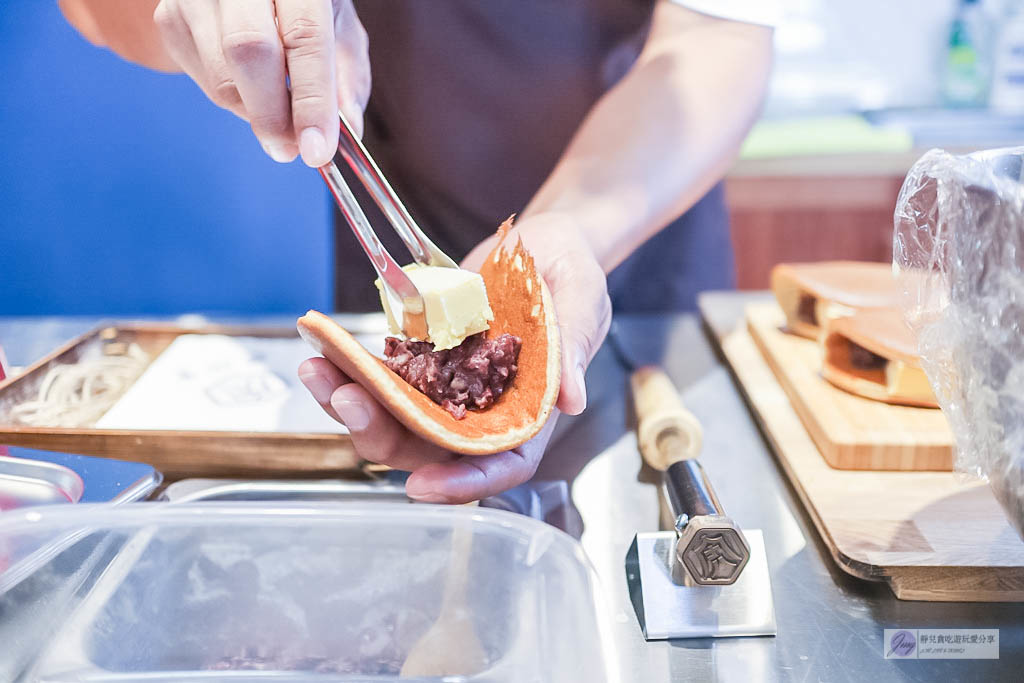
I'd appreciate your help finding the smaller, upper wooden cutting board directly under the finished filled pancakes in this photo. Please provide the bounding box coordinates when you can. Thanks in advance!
[746,301,953,471]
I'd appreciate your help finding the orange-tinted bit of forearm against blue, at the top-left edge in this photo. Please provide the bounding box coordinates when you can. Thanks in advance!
[58,0,180,72]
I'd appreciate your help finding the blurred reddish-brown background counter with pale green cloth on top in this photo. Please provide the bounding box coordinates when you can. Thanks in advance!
[726,109,1024,290]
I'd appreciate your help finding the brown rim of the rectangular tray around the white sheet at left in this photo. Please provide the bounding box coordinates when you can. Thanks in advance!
[0,324,359,480]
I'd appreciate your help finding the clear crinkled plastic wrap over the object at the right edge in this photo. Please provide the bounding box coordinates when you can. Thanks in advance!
[893,147,1024,538]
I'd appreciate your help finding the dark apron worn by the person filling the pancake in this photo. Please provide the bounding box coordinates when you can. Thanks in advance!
[335,0,733,311]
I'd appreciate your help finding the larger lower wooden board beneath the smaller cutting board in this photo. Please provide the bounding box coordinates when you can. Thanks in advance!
[706,300,1024,602]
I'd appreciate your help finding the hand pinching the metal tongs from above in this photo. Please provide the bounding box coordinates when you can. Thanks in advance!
[153,0,370,168]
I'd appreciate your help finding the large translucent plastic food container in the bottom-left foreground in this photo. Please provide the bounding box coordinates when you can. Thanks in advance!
[0,503,612,682]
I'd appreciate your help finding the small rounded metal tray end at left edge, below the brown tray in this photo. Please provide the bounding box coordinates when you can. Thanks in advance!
[0,456,85,512]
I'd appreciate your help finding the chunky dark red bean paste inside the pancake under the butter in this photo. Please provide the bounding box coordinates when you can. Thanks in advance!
[384,332,522,420]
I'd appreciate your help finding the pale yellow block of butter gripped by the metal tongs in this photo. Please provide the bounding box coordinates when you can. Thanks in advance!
[376,263,495,351]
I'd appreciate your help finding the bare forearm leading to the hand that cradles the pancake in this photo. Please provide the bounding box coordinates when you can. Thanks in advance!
[524,2,771,271]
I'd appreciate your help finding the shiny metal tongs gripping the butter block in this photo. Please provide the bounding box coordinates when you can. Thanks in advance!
[319,112,459,340]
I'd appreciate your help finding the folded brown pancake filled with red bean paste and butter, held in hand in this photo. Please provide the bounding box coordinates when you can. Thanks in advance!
[298,218,561,455]
